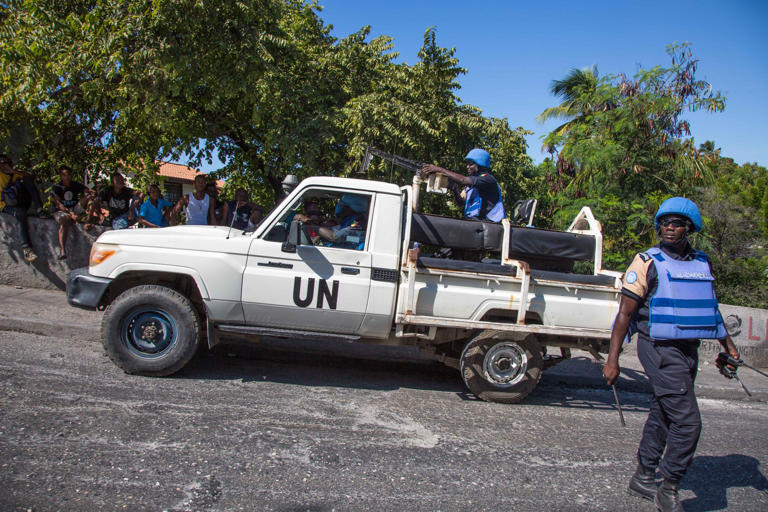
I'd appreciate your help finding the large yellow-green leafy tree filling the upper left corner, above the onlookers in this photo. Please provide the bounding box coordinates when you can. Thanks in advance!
[0,0,306,188]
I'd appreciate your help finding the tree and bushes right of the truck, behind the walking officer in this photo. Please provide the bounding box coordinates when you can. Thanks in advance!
[538,45,768,307]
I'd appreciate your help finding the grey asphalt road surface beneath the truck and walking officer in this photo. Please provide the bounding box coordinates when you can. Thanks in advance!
[0,287,768,512]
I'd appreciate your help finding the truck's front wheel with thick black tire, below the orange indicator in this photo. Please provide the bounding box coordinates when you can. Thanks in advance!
[101,285,200,377]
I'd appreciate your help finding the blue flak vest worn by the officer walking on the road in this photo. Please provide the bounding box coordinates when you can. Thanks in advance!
[645,247,727,340]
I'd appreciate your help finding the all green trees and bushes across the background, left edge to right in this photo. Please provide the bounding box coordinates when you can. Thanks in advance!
[0,0,768,307]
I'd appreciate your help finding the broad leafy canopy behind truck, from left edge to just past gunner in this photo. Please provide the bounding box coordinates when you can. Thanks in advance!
[0,0,531,208]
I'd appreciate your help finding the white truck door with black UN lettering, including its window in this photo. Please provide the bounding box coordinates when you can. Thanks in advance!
[242,187,374,334]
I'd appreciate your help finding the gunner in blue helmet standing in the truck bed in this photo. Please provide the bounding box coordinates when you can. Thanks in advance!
[421,148,506,222]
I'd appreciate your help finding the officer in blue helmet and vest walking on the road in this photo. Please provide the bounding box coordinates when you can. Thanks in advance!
[603,197,739,512]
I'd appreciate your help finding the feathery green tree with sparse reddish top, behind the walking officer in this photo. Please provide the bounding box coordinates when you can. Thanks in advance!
[542,45,725,268]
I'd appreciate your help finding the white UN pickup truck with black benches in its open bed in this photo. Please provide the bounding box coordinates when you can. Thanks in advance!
[67,172,621,403]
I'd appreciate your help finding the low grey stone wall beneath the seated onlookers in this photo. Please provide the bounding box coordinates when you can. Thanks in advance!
[0,213,107,290]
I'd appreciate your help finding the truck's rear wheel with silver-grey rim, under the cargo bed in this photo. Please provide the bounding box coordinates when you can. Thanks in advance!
[459,331,542,404]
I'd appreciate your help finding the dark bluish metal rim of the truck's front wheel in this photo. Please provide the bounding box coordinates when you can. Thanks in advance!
[121,308,179,359]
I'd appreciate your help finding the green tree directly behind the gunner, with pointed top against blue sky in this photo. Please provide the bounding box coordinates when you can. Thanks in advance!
[344,28,533,215]
